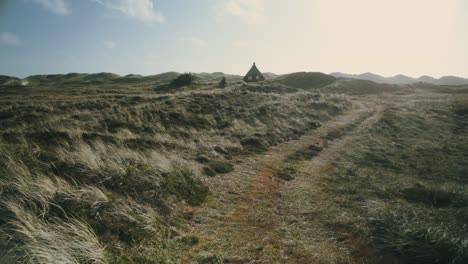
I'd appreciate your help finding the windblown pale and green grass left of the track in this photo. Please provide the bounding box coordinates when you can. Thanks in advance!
[0,76,348,263]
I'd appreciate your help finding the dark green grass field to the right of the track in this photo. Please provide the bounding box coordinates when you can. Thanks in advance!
[327,98,468,264]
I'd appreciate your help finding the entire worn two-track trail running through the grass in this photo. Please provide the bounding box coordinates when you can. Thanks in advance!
[181,100,384,263]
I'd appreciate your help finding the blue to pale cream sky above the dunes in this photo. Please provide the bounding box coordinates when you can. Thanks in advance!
[0,0,468,77]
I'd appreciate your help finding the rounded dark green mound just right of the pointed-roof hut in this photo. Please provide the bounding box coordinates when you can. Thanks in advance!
[271,72,336,89]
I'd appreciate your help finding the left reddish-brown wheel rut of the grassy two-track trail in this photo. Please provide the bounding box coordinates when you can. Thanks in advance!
[181,100,382,263]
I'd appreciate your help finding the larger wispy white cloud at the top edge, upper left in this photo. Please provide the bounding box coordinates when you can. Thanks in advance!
[93,0,165,22]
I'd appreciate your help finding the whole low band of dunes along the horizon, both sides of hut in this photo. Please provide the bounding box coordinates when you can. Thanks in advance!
[4,72,468,89]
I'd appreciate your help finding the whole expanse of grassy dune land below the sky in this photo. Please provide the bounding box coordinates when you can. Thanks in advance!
[0,73,468,263]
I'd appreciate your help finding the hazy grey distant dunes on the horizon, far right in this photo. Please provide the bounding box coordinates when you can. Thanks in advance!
[330,72,468,85]
